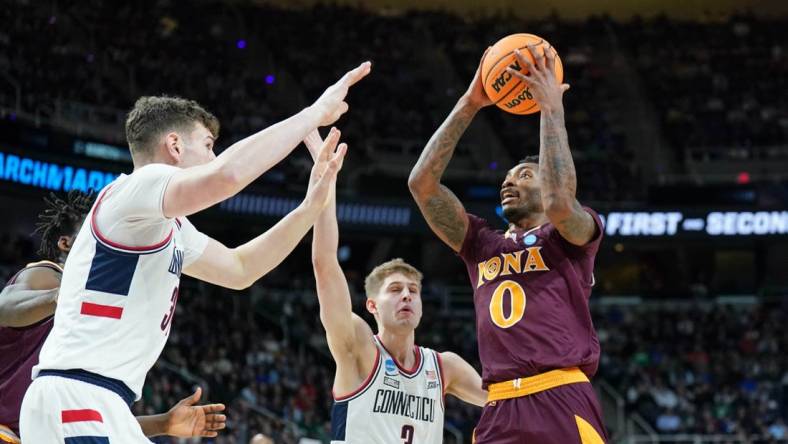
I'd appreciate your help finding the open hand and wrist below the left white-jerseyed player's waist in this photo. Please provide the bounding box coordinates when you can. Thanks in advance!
[137,387,227,438]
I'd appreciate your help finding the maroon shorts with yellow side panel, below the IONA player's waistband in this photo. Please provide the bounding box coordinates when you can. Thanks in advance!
[474,382,607,444]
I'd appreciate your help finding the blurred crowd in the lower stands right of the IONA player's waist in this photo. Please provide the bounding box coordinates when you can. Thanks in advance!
[594,303,788,442]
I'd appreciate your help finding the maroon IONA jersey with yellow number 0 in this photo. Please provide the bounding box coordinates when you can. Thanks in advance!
[459,208,603,387]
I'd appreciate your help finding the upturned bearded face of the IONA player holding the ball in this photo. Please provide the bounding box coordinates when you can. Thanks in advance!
[501,163,543,222]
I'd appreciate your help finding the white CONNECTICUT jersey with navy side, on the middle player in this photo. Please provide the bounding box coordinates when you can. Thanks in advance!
[331,336,444,444]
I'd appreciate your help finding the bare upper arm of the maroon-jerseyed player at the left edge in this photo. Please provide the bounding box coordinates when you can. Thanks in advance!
[0,267,60,328]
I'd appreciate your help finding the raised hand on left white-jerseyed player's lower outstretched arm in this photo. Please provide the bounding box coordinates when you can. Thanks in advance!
[305,128,347,211]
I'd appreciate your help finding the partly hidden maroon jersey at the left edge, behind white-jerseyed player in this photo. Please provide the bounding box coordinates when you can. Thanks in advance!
[0,262,62,435]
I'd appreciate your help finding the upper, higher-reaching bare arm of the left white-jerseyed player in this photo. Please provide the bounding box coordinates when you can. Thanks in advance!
[163,62,371,217]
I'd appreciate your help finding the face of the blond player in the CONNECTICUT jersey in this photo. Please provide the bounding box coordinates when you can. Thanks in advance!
[374,273,421,330]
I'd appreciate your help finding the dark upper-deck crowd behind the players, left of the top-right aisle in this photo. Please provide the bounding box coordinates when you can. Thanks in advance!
[0,0,660,200]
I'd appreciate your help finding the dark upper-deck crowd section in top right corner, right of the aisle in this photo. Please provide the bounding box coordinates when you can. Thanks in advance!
[617,15,788,160]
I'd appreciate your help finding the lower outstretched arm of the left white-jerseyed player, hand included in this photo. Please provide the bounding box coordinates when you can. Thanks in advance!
[183,131,346,289]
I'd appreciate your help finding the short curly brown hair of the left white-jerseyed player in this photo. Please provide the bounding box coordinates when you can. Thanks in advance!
[126,96,219,158]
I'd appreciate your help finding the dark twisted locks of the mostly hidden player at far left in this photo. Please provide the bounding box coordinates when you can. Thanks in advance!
[33,190,96,262]
